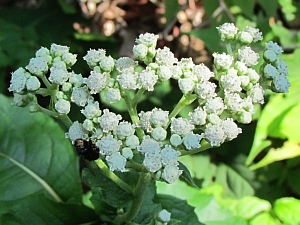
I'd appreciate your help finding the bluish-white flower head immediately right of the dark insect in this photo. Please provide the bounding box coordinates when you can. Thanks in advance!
[95,134,122,155]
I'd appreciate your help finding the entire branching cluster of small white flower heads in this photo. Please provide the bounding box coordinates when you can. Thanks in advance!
[9,23,290,183]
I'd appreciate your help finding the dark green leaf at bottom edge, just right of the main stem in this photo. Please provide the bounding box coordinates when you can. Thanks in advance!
[155,194,203,225]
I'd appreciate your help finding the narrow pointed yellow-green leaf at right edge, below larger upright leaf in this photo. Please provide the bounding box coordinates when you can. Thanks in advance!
[250,141,300,170]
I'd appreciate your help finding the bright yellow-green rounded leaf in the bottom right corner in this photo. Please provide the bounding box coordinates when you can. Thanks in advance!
[274,197,300,225]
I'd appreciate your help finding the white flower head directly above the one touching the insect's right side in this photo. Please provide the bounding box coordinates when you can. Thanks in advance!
[98,109,122,132]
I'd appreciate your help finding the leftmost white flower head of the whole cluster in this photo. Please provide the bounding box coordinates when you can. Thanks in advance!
[8,68,30,93]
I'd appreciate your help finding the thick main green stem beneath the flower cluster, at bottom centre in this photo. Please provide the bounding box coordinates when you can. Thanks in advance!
[113,173,151,224]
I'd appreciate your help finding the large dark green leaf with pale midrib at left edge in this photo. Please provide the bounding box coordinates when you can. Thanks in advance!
[0,95,96,224]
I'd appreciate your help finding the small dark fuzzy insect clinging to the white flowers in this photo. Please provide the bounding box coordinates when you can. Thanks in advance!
[74,139,99,161]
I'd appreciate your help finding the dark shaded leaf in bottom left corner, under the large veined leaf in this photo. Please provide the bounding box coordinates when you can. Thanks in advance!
[0,193,100,225]
